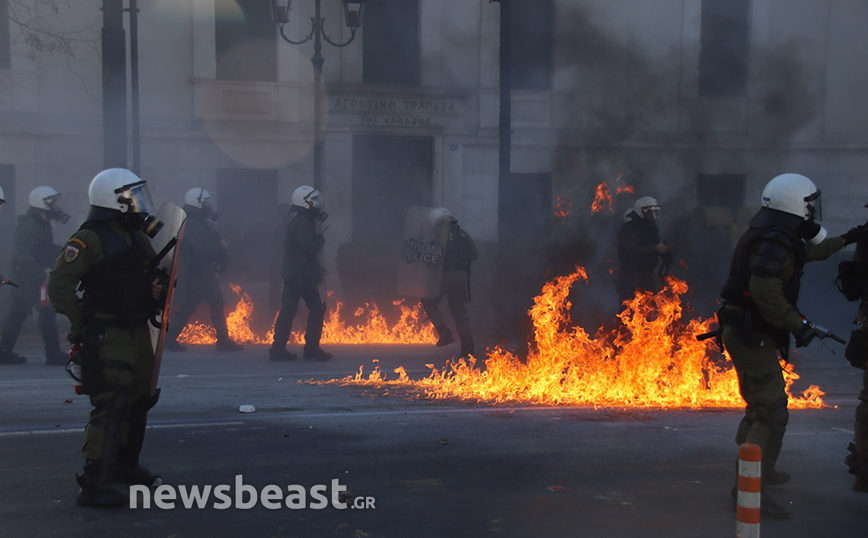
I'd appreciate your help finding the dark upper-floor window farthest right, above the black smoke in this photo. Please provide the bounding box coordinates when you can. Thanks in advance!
[699,0,748,97]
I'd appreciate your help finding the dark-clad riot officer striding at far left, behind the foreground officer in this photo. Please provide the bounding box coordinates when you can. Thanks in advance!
[0,186,69,365]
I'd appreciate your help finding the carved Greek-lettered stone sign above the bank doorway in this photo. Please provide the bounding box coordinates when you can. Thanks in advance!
[328,95,464,128]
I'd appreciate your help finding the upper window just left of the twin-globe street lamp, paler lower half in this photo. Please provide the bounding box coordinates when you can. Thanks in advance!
[214,0,277,81]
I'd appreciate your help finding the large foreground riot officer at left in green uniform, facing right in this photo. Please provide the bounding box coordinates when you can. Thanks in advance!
[48,168,168,506]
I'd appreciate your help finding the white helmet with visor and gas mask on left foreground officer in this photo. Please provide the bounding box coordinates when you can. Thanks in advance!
[87,168,163,238]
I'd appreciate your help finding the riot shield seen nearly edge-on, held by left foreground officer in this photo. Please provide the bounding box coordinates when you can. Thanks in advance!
[150,202,187,395]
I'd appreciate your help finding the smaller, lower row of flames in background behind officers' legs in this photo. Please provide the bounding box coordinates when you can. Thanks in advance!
[178,284,437,344]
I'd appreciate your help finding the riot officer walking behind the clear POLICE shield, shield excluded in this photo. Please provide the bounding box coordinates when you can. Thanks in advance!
[422,207,479,355]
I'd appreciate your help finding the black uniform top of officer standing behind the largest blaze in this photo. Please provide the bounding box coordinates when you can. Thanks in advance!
[617,209,661,302]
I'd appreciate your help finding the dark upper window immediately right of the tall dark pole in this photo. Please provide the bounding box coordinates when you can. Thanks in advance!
[509,0,554,90]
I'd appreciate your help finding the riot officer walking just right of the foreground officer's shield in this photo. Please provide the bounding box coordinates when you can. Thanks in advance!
[166,187,244,351]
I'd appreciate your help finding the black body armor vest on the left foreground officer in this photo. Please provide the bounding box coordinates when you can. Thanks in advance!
[81,221,156,327]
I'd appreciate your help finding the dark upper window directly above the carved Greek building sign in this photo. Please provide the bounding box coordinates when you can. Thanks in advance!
[362,0,419,86]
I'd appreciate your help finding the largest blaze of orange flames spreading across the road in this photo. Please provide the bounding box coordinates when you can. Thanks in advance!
[322,267,824,408]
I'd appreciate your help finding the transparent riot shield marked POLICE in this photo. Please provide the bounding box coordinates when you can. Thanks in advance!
[398,206,451,299]
